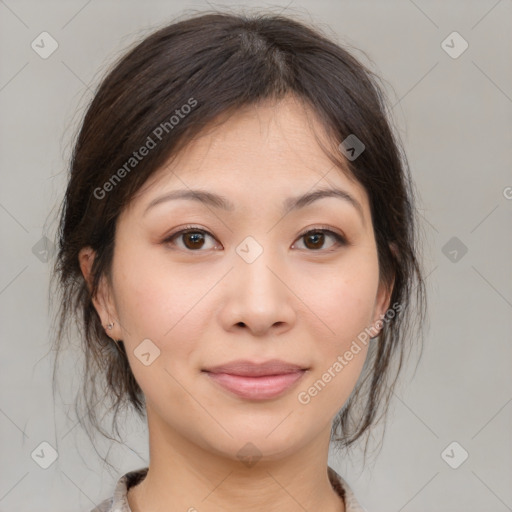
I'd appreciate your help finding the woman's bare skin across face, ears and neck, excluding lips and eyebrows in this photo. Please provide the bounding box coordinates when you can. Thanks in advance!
[80,96,391,512]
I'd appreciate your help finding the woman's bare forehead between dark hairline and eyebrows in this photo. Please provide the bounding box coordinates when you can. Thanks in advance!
[127,96,368,220]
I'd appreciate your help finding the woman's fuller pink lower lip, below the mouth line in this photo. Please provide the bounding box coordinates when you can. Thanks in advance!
[206,370,305,400]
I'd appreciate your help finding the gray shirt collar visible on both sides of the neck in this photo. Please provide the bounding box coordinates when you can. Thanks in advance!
[91,466,366,512]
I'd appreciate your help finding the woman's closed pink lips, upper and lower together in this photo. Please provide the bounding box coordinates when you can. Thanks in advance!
[202,359,308,400]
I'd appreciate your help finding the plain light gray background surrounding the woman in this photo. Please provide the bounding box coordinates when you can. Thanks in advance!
[0,0,512,512]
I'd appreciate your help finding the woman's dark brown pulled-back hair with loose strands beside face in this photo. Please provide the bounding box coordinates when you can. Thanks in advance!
[50,11,426,470]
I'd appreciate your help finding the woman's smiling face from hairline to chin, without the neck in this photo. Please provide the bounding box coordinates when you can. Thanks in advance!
[81,93,390,459]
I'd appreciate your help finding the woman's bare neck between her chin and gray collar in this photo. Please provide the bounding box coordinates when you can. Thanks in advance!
[128,410,345,512]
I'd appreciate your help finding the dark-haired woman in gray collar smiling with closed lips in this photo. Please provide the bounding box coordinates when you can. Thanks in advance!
[54,9,425,512]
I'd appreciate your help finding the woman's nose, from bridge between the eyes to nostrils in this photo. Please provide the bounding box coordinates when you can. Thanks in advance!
[220,249,297,336]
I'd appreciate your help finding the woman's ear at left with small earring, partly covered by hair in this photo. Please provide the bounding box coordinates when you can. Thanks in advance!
[78,247,122,340]
